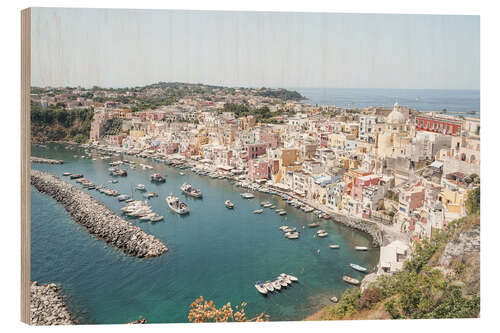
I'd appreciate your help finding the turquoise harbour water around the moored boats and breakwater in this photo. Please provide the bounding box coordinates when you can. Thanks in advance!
[31,144,379,323]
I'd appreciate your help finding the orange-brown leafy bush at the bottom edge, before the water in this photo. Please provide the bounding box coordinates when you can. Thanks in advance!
[188,296,269,323]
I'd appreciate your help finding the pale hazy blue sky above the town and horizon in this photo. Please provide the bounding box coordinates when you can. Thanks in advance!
[31,8,480,89]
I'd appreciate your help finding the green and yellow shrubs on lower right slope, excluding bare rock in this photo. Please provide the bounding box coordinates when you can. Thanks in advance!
[323,214,480,320]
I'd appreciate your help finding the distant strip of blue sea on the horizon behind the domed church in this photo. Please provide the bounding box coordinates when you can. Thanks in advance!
[288,88,481,118]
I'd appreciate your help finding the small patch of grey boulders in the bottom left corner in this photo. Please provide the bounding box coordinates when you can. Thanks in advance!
[30,281,74,325]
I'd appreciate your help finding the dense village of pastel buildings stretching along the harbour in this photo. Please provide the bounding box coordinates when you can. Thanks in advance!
[32,85,480,274]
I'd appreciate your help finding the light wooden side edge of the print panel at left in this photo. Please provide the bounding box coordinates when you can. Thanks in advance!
[21,8,31,324]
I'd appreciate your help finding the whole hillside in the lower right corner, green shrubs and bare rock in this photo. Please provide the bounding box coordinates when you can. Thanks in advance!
[306,214,480,320]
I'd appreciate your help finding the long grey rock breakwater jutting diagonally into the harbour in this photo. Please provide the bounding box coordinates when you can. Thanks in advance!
[31,170,168,258]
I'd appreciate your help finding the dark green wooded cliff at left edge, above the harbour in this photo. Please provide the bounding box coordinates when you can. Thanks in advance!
[31,103,94,142]
